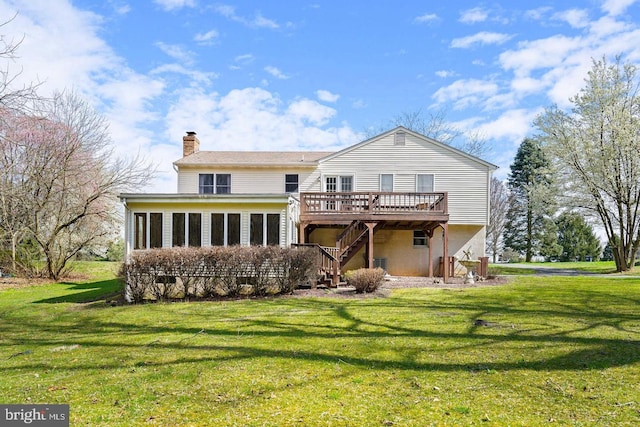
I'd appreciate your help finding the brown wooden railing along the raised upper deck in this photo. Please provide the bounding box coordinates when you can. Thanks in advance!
[300,192,448,215]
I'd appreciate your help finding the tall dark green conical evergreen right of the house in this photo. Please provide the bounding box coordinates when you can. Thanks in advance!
[504,138,555,262]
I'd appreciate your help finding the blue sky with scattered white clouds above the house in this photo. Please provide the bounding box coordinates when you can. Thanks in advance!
[0,0,640,192]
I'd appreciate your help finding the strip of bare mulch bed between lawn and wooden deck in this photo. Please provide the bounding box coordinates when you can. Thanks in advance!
[293,276,510,298]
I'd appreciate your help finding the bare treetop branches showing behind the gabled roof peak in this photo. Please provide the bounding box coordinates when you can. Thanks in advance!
[365,109,489,157]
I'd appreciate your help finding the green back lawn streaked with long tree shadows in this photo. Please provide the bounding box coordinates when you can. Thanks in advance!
[0,262,640,426]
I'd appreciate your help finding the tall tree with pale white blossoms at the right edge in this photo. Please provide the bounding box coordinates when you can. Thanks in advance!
[536,58,640,271]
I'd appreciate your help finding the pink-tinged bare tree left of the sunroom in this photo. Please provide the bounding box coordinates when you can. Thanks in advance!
[0,93,154,279]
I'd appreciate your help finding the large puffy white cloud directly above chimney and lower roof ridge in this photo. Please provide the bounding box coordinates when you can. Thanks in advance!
[166,88,362,155]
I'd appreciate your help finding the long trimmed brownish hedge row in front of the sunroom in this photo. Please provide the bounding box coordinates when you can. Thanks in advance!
[121,246,319,303]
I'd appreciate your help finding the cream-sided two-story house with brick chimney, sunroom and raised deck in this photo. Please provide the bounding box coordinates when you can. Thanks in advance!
[120,127,497,280]
